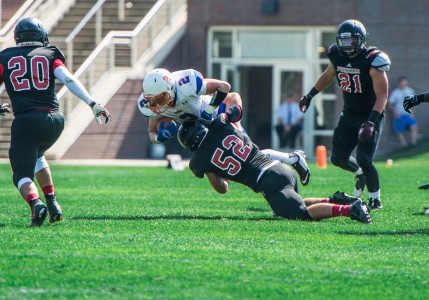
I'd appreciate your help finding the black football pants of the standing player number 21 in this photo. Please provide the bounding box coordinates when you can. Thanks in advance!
[331,114,385,192]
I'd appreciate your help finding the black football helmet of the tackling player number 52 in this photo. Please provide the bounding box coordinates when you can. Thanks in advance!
[177,121,209,152]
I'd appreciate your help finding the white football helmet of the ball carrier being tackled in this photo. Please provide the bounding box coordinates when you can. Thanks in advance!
[143,69,176,113]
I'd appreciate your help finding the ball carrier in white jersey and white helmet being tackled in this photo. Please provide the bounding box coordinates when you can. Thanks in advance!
[137,69,311,185]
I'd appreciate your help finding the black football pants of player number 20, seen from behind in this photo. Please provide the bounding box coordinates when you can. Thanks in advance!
[9,111,64,186]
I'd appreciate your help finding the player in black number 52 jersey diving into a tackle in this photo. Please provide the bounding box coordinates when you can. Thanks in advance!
[177,105,372,223]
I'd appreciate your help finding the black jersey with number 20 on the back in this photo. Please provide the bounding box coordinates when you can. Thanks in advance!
[0,46,65,114]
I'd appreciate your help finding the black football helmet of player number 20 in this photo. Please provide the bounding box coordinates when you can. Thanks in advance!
[14,18,49,46]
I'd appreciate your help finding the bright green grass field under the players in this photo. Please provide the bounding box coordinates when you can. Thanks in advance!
[0,154,429,299]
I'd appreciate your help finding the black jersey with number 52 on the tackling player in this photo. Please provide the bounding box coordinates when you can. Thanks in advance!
[189,114,273,192]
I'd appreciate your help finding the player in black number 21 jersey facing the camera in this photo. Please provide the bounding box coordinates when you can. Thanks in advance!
[299,20,390,209]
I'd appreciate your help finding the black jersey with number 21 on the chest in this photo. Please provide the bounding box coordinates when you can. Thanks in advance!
[328,44,390,114]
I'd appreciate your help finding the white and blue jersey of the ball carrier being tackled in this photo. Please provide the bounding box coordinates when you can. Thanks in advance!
[137,69,211,123]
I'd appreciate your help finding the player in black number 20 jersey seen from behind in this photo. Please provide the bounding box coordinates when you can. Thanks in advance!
[0,18,110,226]
